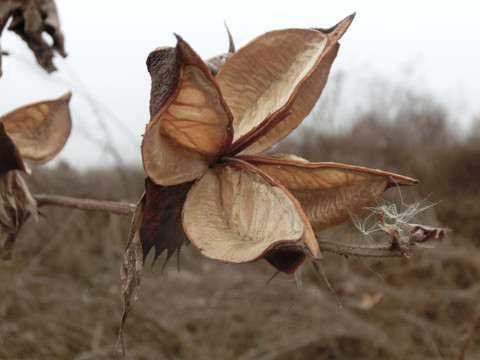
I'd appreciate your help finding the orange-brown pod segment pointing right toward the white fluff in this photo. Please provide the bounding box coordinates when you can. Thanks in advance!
[239,156,418,232]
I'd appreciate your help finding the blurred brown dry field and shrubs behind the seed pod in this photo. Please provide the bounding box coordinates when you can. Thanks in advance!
[0,79,480,360]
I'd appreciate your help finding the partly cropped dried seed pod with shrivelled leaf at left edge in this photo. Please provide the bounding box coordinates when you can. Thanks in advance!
[0,93,71,260]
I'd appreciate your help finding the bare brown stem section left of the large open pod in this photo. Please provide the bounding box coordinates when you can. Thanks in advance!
[33,194,136,216]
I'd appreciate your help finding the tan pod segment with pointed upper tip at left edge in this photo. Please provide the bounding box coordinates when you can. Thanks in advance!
[0,93,72,163]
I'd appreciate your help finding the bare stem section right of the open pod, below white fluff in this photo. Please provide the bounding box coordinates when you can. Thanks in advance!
[317,240,408,258]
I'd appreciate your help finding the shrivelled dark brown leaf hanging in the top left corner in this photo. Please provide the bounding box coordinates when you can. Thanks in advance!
[0,0,67,76]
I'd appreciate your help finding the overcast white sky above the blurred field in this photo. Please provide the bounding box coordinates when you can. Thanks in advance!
[0,0,480,167]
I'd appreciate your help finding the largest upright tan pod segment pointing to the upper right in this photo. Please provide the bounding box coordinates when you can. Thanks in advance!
[216,15,353,154]
